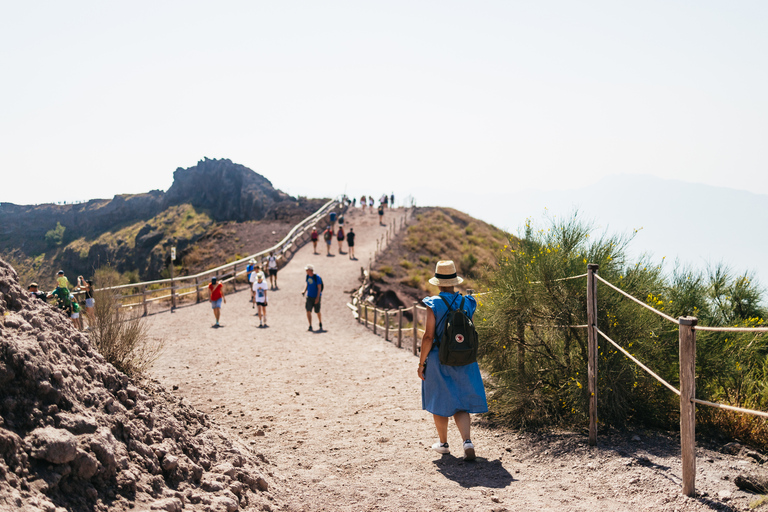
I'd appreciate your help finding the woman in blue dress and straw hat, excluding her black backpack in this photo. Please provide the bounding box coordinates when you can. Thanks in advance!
[418,260,488,460]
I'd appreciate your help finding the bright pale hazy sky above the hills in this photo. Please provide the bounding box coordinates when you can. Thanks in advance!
[0,0,768,227]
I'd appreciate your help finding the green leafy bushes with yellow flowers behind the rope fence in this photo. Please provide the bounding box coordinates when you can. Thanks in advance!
[475,216,768,446]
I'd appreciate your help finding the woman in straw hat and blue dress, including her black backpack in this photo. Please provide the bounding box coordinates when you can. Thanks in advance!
[418,260,488,460]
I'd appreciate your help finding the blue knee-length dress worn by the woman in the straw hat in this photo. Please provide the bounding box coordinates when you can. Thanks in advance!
[421,292,488,416]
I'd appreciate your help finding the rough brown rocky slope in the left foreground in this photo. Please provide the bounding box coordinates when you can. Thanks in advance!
[0,260,279,512]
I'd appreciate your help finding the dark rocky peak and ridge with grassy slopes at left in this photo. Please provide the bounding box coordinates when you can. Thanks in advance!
[0,158,320,280]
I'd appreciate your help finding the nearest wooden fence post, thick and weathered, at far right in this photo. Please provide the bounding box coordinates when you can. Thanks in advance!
[679,316,698,497]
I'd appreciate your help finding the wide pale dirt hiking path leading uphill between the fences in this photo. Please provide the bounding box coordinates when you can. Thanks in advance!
[150,210,750,511]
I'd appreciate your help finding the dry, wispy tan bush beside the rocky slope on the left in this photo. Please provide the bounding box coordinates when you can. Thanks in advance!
[90,267,164,376]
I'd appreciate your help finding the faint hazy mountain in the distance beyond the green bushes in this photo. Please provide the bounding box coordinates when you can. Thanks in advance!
[415,175,768,287]
